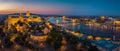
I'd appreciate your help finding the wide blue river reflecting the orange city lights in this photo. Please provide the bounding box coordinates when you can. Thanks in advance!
[48,18,120,41]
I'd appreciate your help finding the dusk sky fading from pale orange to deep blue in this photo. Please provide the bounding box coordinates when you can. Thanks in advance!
[0,0,120,16]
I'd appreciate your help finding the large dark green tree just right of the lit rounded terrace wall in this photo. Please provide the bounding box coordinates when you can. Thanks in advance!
[46,29,62,49]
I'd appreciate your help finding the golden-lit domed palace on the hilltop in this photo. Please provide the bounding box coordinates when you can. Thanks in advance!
[8,11,41,25]
